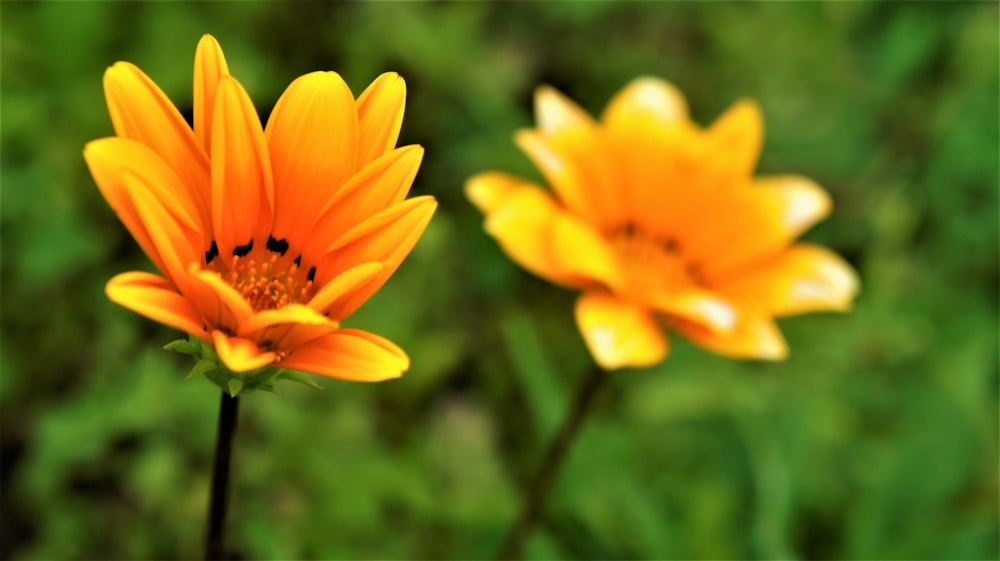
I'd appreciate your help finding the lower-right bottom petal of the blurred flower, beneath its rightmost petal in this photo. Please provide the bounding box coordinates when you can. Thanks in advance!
[674,307,788,360]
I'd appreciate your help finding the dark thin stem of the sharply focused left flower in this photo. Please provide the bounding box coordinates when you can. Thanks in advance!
[205,392,240,560]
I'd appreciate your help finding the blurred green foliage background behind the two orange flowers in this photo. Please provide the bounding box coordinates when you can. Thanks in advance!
[0,2,1000,559]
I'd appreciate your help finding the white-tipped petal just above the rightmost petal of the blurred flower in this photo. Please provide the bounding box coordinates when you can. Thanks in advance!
[685,176,832,282]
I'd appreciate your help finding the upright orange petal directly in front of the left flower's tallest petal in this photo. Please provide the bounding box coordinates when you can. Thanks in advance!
[212,76,274,262]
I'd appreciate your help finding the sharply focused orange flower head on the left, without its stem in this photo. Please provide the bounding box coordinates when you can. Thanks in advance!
[84,35,437,381]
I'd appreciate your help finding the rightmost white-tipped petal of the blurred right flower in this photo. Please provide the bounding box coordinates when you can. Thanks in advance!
[719,244,858,316]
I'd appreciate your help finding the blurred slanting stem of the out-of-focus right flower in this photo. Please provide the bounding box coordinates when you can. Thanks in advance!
[497,366,607,559]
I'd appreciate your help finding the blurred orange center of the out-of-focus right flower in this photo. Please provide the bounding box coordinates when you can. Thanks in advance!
[606,222,705,299]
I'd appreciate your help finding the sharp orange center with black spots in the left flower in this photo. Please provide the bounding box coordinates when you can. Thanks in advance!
[205,237,316,312]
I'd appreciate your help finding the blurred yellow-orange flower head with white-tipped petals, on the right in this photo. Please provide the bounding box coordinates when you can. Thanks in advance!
[466,78,857,369]
